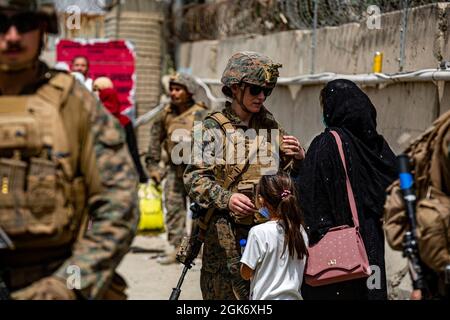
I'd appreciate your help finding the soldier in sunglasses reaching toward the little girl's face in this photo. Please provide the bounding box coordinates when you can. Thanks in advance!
[184,52,304,299]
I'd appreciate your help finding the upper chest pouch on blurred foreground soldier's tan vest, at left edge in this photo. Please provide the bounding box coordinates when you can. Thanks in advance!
[0,115,42,157]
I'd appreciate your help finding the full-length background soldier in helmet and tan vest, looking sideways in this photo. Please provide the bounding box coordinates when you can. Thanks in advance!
[145,73,207,264]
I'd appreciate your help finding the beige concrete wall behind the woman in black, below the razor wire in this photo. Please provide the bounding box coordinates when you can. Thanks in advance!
[178,3,450,299]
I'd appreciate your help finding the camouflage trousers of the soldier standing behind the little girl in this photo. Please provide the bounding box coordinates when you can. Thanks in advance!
[200,215,250,300]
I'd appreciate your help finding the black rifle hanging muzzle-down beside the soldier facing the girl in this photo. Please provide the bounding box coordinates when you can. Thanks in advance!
[169,202,207,300]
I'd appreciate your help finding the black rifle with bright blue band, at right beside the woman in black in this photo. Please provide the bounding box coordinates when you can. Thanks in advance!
[397,154,430,297]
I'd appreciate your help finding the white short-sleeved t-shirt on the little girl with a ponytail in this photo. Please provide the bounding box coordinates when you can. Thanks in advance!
[241,221,308,300]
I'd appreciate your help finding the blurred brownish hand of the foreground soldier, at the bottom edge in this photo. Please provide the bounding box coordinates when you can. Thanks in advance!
[11,277,77,300]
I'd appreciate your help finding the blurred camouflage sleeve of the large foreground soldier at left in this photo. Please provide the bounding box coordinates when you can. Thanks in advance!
[55,99,139,299]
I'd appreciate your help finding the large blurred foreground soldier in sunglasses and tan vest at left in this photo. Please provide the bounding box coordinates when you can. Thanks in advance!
[0,0,138,300]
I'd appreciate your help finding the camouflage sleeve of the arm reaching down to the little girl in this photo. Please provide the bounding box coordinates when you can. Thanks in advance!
[183,118,232,209]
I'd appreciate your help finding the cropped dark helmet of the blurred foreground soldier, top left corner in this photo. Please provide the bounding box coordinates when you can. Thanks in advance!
[0,0,58,34]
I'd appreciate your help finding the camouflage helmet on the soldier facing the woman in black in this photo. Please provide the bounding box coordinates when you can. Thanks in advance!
[221,51,281,95]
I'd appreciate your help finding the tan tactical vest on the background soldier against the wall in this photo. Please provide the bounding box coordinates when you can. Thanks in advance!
[164,103,207,156]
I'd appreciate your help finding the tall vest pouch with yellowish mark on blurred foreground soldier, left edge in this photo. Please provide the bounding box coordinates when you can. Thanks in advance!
[0,158,27,233]
